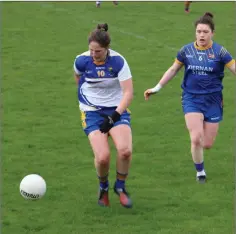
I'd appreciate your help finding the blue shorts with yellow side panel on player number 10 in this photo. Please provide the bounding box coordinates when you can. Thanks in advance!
[81,108,130,136]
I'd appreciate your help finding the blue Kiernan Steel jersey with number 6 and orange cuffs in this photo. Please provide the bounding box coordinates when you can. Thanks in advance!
[176,42,235,94]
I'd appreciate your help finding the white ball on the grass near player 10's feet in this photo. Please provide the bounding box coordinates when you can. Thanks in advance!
[20,174,47,200]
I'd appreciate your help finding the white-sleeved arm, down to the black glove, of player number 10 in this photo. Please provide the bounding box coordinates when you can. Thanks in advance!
[116,59,133,114]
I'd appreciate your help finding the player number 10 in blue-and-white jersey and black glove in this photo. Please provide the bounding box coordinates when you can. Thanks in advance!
[74,24,133,208]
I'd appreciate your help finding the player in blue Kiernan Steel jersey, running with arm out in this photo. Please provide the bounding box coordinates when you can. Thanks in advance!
[144,12,236,183]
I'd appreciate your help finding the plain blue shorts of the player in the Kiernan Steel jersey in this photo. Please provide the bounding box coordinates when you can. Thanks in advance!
[182,92,223,123]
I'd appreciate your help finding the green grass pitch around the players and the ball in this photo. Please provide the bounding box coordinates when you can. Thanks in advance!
[1,2,236,234]
